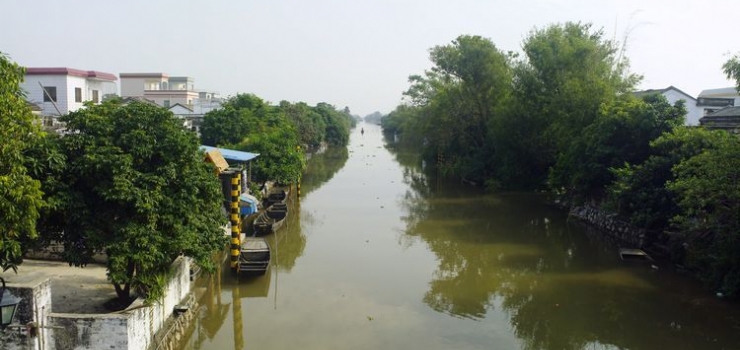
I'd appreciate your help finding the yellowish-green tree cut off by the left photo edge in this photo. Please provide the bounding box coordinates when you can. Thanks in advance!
[0,53,43,271]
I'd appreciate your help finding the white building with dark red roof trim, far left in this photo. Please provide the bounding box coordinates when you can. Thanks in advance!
[21,67,118,116]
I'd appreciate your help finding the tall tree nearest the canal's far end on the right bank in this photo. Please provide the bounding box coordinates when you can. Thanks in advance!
[402,35,511,182]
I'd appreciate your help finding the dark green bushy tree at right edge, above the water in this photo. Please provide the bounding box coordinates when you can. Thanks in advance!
[667,136,740,296]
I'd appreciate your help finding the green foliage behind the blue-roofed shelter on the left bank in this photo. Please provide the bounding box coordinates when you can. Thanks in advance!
[201,94,355,183]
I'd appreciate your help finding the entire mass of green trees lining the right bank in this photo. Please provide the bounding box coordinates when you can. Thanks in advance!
[382,22,740,297]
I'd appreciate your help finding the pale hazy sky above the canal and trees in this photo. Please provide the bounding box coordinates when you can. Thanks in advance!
[0,0,740,116]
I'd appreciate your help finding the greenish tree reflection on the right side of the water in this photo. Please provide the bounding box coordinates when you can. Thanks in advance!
[388,140,740,349]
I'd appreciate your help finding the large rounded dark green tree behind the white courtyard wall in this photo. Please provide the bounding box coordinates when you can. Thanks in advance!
[55,101,226,302]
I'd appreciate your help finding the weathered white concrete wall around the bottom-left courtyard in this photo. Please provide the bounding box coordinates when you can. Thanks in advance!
[0,257,191,350]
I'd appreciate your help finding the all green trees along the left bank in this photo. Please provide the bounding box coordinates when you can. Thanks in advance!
[0,53,354,308]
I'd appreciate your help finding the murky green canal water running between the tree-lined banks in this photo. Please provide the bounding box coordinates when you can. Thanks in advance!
[180,124,740,350]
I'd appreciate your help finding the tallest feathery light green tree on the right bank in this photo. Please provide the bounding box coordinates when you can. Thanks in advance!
[497,22,640,188]
